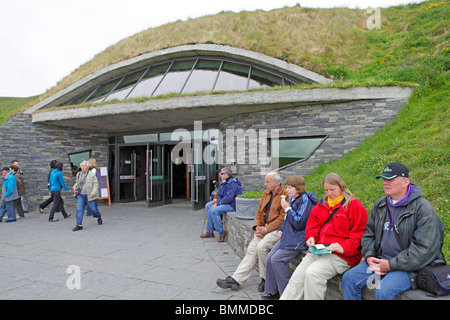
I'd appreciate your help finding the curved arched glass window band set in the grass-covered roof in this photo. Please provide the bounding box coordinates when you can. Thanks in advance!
[62,56,301,105]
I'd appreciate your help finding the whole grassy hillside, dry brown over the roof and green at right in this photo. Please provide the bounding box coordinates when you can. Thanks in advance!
[0,0,450,261]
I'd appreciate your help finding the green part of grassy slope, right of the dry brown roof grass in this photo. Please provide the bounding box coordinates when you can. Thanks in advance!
[305,1,450,261]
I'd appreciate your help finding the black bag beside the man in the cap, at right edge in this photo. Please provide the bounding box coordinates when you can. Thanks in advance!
[417,260,450,297]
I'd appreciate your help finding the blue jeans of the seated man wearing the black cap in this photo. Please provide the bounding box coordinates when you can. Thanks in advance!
[342,261,411,300]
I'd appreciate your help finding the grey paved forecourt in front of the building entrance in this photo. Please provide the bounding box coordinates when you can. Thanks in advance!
[0,201,260,300]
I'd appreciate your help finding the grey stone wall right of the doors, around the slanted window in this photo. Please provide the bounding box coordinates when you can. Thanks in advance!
[220,99,405,191]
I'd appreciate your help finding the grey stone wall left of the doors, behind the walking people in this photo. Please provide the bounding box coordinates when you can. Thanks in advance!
[0,113,108,211]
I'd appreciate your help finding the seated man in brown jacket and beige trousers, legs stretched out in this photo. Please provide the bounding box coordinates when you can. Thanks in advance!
[216,172,287,292]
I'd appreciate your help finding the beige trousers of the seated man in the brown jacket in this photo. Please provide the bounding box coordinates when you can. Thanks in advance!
[232,230,278,286]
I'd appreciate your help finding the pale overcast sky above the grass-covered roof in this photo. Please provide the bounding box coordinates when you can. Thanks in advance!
[0,0,421,97]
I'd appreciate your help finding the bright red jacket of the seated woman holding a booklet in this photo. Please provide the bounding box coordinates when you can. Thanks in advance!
[305,197,368,268]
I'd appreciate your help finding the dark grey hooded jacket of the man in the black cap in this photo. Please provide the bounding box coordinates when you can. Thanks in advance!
[361,183,445,289]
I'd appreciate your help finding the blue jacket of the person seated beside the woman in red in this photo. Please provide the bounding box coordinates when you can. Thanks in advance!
[278,191,318,251]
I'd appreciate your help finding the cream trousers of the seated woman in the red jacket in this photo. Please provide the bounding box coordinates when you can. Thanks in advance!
[280,252,350,300]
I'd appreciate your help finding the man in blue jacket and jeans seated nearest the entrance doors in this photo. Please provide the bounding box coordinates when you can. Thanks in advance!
[200,167,242,242]
